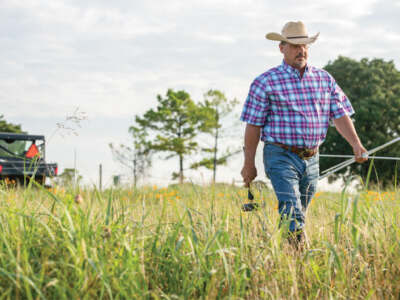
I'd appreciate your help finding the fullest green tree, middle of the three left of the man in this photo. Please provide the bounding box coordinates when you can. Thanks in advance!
[135,89,208,183]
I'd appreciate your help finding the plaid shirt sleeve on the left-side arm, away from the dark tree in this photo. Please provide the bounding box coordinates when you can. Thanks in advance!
[240,78,269,126]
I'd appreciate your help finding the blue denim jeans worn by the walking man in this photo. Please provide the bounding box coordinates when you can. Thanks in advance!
[264,143,319,232]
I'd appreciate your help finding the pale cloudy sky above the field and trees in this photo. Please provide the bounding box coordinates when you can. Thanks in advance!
[0,0,400,185]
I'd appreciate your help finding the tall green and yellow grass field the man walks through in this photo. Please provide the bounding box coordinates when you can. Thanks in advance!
[0,184,400,299]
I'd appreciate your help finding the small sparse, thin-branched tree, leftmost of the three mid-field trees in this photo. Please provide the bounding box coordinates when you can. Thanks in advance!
[109,126,151,188]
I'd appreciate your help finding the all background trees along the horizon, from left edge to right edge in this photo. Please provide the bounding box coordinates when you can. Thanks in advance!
[0,56,400,187]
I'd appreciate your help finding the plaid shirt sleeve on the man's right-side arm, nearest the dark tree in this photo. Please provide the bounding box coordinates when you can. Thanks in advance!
[329,77,354,120]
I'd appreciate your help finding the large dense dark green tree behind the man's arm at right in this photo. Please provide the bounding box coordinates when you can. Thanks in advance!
[320,56,400,187]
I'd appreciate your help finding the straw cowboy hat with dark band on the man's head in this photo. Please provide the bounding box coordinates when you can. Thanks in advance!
[265,21,319,45]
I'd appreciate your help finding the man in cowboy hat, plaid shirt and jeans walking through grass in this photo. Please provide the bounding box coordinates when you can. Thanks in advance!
[241,21,367,244]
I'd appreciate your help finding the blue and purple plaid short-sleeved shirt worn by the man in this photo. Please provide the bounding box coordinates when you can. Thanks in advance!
[240,61,354,148]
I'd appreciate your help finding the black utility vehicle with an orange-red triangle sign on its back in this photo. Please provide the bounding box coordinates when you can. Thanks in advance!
[0,132,57,184]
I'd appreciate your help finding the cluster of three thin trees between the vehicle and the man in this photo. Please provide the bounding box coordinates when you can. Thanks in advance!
[110,89,240,185]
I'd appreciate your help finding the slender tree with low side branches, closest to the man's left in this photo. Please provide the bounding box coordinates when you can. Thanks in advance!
[191,90,241,183]
